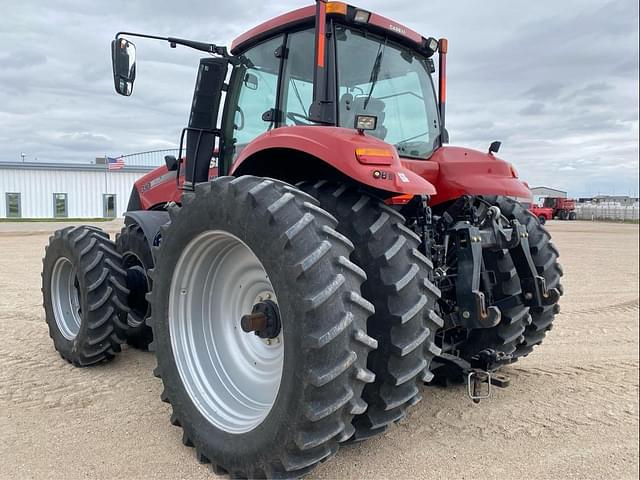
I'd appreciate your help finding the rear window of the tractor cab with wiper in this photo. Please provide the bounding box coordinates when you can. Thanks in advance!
[336,26,440,158]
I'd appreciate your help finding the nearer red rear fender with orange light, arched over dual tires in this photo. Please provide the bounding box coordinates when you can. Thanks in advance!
[229,126,436,195]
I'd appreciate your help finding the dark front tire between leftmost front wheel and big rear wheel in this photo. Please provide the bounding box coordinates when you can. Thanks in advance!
[116,223,153,350]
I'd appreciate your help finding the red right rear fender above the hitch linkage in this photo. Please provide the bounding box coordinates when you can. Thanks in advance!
[402,147,531,205]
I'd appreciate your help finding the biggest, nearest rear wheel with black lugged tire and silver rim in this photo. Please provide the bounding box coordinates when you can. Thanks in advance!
[150,176,376,478]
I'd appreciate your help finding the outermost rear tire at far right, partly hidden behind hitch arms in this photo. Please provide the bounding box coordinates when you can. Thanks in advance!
[488,197,564,358]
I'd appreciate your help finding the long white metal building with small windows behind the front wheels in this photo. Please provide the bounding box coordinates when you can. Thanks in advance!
[0,162,153,218]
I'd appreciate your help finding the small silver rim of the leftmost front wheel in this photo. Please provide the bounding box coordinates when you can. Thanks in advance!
[51,257,82,340]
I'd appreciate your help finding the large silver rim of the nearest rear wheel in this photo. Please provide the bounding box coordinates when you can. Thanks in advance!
[168,230,284,434]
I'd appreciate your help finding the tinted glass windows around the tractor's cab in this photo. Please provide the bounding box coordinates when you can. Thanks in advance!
[228,11,441,158]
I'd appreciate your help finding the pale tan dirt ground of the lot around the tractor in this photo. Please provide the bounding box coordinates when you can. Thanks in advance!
[0,222,639,479]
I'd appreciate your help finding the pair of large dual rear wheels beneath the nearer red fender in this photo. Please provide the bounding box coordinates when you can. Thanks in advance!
[146,176,441,478]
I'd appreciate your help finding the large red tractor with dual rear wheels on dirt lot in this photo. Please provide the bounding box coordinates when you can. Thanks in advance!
[43,0,562,478]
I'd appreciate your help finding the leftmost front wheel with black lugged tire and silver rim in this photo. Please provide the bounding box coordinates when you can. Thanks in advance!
[42,226,129,367]
